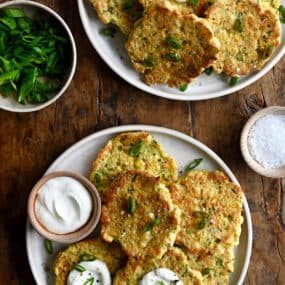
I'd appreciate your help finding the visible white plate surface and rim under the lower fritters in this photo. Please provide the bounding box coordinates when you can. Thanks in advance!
[26,125,252,285]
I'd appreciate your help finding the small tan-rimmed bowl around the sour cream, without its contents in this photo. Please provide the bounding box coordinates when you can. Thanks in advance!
[27,171,101,243]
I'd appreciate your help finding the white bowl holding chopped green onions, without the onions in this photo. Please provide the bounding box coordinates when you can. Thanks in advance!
[0,0,77,113]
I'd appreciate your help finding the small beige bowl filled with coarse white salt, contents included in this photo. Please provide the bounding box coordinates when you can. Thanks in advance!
[240,106,285,178]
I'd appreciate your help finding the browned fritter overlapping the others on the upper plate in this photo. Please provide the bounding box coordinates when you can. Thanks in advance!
[126,1,219,87]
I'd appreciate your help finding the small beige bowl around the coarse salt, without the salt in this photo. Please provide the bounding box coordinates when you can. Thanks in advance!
[240,106,285,178]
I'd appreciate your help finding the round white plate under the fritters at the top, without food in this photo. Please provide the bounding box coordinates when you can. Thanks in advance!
[77,0,285,101]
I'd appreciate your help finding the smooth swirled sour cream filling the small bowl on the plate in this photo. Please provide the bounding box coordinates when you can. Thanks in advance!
[35,177,93,234]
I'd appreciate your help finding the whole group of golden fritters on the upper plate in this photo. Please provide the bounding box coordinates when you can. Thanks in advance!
[90,0,281,87]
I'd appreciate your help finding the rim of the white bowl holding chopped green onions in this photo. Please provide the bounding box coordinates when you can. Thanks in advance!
[0,0,77,113]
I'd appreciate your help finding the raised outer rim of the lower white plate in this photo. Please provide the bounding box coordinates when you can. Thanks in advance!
[25,124,252,285]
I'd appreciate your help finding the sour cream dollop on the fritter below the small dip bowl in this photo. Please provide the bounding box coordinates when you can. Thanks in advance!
[67,260,111,285]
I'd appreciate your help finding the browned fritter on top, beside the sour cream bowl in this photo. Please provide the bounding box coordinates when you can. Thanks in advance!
[101,171,180,258]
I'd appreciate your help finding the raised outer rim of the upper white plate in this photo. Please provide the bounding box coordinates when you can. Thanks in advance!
[77,0,285,101]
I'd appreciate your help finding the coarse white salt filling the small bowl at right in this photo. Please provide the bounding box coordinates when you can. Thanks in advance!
[248,114,285,168]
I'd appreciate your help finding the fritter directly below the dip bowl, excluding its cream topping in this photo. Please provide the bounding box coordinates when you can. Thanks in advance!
[54,237,126,285]
